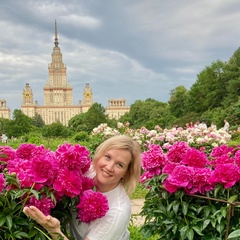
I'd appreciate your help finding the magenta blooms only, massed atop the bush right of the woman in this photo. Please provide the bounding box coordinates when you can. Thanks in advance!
[140,142,240,194]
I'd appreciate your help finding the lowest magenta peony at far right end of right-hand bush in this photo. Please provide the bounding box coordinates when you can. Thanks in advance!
[209,163,240,188]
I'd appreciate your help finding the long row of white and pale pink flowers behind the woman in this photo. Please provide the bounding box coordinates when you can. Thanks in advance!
[90,123,231,151]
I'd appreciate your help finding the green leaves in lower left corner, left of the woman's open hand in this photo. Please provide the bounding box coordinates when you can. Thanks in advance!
[0,172,55,240]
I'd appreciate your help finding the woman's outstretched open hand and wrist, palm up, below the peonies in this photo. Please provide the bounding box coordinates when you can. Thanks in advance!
[23,206,68,240]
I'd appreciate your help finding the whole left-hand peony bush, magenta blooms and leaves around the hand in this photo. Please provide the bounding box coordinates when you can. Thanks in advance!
[0,143,108,240]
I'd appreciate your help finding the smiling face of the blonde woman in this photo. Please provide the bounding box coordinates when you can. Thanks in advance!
[94,149,132,192]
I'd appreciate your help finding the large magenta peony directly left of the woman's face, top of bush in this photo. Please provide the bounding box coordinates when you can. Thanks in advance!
[55,143,91,174]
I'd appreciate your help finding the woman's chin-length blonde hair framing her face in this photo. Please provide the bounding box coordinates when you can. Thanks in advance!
[92,135,141,194]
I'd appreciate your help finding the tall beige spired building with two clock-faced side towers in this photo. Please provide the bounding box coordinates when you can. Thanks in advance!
[21,22,93,125]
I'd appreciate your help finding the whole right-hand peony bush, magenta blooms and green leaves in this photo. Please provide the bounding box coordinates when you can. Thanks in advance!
[141,141,240,240]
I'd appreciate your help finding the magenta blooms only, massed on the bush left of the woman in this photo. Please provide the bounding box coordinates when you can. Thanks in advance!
[0,143,108,222]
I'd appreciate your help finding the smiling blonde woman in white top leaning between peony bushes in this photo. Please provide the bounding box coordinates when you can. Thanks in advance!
[24,135,141,240]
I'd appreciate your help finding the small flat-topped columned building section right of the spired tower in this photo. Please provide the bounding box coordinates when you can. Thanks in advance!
[105,99,130,119]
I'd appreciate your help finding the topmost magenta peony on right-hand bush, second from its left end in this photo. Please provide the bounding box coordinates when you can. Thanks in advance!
[167,142,191,163]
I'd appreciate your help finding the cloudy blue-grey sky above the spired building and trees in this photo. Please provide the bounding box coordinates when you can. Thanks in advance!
[0,0,240,116]
